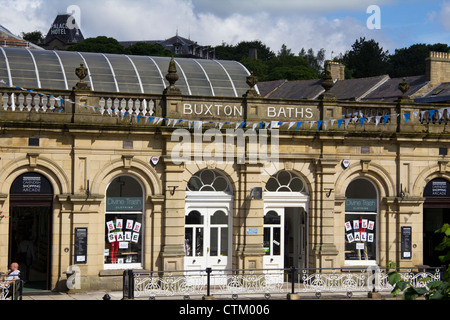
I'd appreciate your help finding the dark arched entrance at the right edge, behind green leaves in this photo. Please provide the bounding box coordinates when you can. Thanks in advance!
[423,178,450,267]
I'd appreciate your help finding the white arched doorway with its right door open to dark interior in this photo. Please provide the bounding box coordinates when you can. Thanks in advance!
[263,170,309,269]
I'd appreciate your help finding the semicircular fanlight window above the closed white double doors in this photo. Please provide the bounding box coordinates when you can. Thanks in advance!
[186,169,232,193]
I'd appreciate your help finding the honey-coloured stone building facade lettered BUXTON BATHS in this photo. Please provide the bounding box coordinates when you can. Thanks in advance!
[0,51,450,290]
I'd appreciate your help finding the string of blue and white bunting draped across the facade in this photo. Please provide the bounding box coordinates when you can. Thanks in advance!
[0,79,444,131]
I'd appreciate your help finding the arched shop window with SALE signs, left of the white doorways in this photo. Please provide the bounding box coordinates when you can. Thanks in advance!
[104,176,144,268]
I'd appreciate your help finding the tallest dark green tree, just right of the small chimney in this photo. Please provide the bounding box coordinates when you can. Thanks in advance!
[340,37,389,78]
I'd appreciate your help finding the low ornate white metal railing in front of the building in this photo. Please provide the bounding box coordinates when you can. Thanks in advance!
[123,267,441,299]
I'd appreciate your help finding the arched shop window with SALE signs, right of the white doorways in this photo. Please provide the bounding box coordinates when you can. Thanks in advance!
[345,178,378,264]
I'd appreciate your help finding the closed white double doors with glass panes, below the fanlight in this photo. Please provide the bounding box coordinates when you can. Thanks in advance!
[184,207,231,270]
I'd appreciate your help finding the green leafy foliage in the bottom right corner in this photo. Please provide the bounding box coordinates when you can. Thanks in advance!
[388,223,450,300]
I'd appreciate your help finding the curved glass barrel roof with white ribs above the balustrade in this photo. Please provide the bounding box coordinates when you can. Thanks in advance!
[0,47,255,97]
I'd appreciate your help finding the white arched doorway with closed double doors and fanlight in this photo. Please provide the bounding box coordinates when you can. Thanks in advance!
[184,169,233,270]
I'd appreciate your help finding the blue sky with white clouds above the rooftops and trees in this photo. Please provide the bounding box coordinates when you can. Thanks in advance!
[0,0,450,58]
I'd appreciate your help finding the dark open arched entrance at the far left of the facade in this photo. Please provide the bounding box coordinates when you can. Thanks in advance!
[9,173,53,290]
